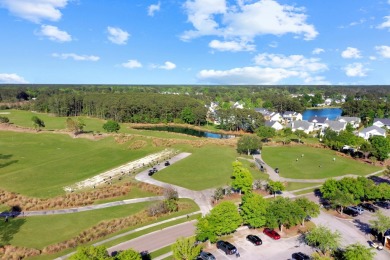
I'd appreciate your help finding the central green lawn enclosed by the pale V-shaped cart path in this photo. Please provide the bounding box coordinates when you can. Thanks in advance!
[153,145,260,190]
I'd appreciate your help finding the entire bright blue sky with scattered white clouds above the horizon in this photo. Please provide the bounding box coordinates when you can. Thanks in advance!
[0,0,390,85]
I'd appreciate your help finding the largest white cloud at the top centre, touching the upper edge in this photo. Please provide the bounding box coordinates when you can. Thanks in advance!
[181,0,318,47]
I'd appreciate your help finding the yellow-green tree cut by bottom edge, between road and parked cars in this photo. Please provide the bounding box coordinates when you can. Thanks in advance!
[171,237,202,260]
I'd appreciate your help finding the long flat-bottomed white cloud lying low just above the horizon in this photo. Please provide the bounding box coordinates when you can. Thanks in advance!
[198,53,329,84]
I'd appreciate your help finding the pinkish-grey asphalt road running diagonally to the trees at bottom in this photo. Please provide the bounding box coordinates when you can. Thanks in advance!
[108,220,196,254]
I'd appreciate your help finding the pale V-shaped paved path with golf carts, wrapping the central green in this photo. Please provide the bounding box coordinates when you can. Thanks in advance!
[135,153,213,215]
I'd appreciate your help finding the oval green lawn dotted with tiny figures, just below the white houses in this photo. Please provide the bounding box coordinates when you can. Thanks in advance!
[261,145,382,179]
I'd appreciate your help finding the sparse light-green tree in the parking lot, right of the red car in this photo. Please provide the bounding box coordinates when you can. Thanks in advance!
[305,225,341,254]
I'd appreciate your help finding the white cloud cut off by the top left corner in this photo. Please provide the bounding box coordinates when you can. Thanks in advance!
[0,0,69,23]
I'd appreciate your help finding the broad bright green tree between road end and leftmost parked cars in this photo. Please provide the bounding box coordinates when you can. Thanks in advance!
[196,201,242,242]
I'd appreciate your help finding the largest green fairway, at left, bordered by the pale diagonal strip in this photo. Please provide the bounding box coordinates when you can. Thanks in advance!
[0,131,163,197]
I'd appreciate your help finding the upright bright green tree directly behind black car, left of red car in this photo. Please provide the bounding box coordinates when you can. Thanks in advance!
[240,192,269,228]
